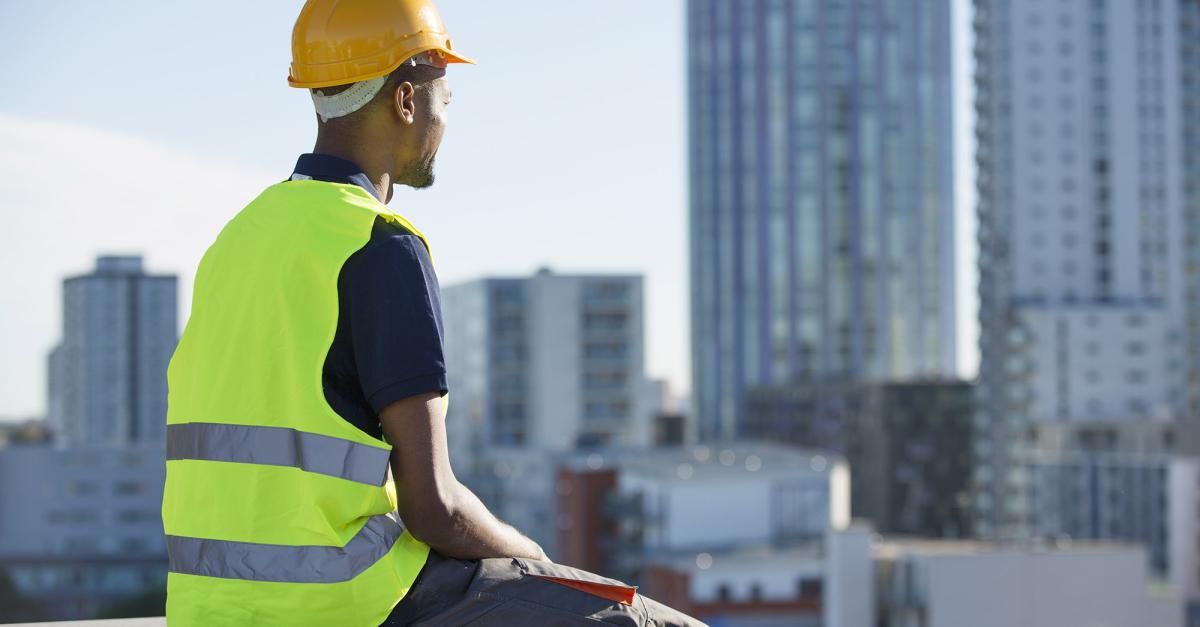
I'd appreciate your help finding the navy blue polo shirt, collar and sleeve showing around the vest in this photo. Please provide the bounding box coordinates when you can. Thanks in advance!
[290,154,448,437]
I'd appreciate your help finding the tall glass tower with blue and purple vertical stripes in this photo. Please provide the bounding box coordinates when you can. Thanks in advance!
[686,0,955,438]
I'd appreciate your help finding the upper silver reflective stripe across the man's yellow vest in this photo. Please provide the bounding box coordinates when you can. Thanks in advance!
[167,423,391,485]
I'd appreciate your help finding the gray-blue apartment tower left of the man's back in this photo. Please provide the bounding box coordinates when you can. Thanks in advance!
[47,257,179,448]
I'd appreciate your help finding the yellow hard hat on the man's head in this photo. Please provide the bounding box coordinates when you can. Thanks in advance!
[288,0,475,89]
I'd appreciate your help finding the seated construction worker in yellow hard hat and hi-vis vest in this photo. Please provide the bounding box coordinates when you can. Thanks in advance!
[162,0,700,626]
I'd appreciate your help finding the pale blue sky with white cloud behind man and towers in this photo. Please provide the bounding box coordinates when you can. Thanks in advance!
[0,0,976,418]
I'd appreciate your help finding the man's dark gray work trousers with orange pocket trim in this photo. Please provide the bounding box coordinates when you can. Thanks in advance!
[383,542,704,627]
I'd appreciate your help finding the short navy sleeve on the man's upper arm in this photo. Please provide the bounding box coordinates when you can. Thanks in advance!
[341,221,448,414]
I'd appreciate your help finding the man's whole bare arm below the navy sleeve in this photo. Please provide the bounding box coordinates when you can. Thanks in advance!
[379,393,550,561]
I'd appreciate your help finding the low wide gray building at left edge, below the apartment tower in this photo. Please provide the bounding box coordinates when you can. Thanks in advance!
[0,443,167,622]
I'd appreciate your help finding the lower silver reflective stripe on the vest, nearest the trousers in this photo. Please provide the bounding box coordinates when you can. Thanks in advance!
[167,514,404,584]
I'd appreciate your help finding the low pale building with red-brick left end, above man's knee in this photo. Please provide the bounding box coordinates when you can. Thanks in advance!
[556,442,851,581]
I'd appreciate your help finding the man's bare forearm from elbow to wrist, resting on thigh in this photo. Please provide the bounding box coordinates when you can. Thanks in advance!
[419,482,547,560]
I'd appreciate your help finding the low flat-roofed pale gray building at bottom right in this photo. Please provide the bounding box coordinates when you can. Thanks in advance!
[864,530,1184,627]
